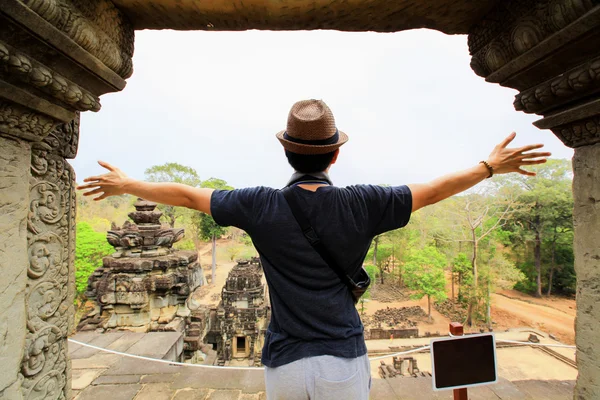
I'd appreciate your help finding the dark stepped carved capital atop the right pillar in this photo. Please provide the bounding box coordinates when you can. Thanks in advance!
[469,0,600,147]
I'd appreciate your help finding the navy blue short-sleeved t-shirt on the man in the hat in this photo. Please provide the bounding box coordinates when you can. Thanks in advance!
[211,185,412,367]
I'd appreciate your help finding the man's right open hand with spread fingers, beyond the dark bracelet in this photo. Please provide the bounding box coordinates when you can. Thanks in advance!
[487,132,550,176]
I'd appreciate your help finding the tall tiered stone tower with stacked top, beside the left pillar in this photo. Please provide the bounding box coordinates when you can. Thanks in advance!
[78,199,203,332]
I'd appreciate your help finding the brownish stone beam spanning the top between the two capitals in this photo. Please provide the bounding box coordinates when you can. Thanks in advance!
[113,0,499,34]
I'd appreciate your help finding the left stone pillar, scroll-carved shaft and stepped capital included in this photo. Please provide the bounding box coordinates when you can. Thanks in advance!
[0,0,133,400]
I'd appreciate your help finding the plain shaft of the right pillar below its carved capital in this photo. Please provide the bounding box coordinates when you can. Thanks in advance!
[573,144,600,400]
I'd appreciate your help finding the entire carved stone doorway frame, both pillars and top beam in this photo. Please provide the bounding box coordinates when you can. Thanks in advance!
[0,0,600,399]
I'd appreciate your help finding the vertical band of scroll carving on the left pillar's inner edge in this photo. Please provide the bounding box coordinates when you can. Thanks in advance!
[21,117,78,399]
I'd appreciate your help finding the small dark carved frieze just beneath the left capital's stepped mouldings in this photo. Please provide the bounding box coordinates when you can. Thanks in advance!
[0,100,58,141]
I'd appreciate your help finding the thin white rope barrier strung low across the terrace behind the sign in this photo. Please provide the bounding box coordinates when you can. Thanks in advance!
[68,339,576,370]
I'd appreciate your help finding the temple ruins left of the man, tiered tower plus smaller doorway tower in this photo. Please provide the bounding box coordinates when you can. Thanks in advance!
[77,206,270,366]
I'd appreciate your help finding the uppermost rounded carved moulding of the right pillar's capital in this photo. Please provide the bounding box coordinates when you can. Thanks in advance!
[468,0,595,77]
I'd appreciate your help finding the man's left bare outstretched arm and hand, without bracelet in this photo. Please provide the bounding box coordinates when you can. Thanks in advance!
[77,161,214,215]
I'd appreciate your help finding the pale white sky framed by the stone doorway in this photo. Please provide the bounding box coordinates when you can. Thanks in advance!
[72,30,573,188]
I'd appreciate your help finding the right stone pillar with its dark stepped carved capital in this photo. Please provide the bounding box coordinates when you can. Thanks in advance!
[469,0,600,400]
